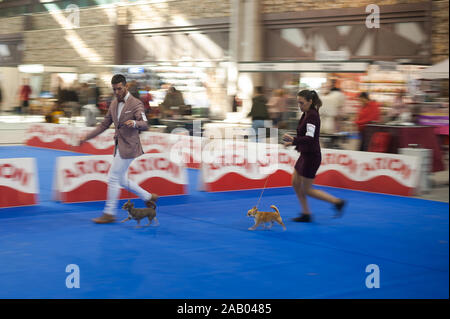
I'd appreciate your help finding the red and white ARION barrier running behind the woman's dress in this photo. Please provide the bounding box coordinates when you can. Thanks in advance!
[200,143,421,196]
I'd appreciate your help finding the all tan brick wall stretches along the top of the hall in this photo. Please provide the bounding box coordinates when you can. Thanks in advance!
[0,0,449,66]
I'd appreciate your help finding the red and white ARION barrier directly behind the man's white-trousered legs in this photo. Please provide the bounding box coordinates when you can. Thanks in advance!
[54,153,187,203]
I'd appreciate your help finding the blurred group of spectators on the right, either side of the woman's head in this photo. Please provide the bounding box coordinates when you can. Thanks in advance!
[247,81,428,151]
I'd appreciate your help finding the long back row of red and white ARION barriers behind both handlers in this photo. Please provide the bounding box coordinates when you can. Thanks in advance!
[26,123,420,196]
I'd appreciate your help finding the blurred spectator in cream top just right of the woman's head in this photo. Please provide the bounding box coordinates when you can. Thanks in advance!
[319,85,345,134]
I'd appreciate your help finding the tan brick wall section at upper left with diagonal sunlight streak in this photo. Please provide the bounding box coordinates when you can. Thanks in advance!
[19,8,117,67]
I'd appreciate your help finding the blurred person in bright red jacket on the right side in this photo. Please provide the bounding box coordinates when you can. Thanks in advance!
[355,92,380,151]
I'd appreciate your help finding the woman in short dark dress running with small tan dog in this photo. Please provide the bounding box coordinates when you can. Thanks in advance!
[283,90,345,222]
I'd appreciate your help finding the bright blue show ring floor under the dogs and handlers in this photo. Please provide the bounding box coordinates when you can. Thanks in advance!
[0,146,449,299]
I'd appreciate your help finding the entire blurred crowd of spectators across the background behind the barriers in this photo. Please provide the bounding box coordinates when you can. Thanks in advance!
[5,74,430,150]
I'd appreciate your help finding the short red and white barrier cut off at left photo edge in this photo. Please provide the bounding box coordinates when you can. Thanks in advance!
[0,158,38,208]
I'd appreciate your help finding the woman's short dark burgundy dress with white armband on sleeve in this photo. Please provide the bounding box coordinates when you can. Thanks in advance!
[293,109,322,178]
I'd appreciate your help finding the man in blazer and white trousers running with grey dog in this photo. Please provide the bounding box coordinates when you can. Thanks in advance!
[80,74,159,224]
